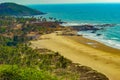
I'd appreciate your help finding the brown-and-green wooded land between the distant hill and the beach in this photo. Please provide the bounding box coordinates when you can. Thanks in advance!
[0,16,62,45]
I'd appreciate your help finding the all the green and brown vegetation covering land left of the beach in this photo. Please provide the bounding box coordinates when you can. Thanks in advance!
[0,16,108,80]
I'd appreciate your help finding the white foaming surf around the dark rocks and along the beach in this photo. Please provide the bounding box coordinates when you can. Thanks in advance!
[61,22,120,50]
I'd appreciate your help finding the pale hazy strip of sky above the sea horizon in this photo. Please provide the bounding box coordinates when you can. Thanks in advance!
[0,0,120,4]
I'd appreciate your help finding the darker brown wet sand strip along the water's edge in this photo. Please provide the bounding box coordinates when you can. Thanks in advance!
[67,36,120,55]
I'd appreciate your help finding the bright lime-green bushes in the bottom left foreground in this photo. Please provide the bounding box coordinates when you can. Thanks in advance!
[0,65,57,80]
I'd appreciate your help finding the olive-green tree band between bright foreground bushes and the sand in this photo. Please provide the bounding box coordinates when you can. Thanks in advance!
[0,44,80,80]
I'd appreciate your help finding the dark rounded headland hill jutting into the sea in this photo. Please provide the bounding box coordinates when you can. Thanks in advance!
[0,3,44,16]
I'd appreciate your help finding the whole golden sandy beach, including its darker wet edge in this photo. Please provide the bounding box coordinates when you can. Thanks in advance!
[31,33,120,80]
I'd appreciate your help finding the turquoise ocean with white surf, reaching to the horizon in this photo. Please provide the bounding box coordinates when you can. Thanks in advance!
[27,3,120,49]
